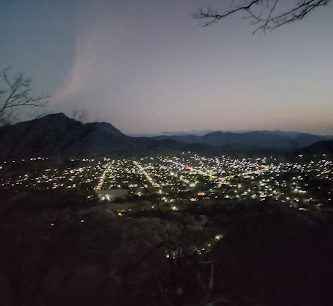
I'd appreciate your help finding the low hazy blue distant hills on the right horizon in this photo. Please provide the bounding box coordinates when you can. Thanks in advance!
[155,131,324,150]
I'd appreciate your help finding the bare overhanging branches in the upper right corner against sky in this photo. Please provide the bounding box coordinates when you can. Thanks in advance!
[193,0,331,33]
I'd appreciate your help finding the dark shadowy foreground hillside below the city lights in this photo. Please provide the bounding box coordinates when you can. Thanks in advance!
[0,190,333,306]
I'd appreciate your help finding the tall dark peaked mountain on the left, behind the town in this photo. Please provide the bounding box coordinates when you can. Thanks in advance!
[0,113,184,160]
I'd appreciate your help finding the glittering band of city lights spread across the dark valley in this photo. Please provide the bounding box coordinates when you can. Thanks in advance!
[0,153,333,211]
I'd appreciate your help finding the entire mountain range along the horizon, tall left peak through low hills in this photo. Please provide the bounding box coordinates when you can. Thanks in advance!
[0,113,326,160]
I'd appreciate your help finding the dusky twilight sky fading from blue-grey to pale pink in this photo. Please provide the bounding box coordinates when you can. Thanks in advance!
[0,0,333,134]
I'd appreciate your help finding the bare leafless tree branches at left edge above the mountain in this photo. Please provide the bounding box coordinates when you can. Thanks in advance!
[0,67,48,126]
